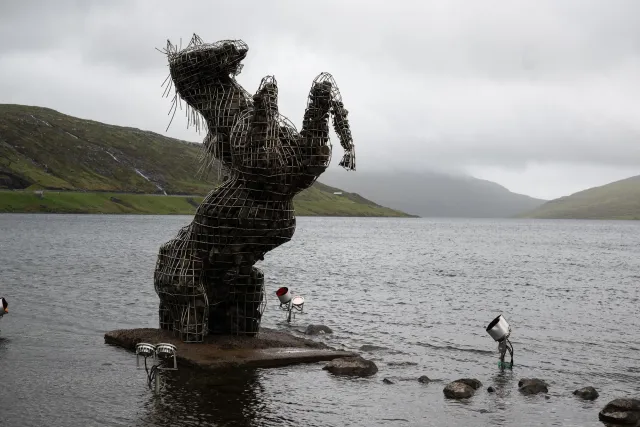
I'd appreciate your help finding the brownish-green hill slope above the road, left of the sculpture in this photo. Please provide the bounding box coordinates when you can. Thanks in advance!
[0,105,213,194]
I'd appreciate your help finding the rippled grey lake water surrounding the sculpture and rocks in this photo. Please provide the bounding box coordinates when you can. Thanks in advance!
[0,215,640,427]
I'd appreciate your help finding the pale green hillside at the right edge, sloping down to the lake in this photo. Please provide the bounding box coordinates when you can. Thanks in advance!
[520,176,640,220]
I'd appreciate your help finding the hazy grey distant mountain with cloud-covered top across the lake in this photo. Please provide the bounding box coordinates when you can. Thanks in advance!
[322,170,545,218]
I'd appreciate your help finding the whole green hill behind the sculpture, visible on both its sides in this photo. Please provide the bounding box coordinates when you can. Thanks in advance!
[0,104,407,216]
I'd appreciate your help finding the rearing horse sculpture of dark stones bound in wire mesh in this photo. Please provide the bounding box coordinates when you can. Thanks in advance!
[154,34,355,342]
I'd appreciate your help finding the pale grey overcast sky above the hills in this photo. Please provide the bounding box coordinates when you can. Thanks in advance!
[0,0,640,198]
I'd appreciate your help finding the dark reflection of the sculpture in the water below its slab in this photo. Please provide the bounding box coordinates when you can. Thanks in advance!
[140,368,268,427]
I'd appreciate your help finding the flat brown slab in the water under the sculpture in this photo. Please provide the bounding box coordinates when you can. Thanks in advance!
[104,328,356,369]
